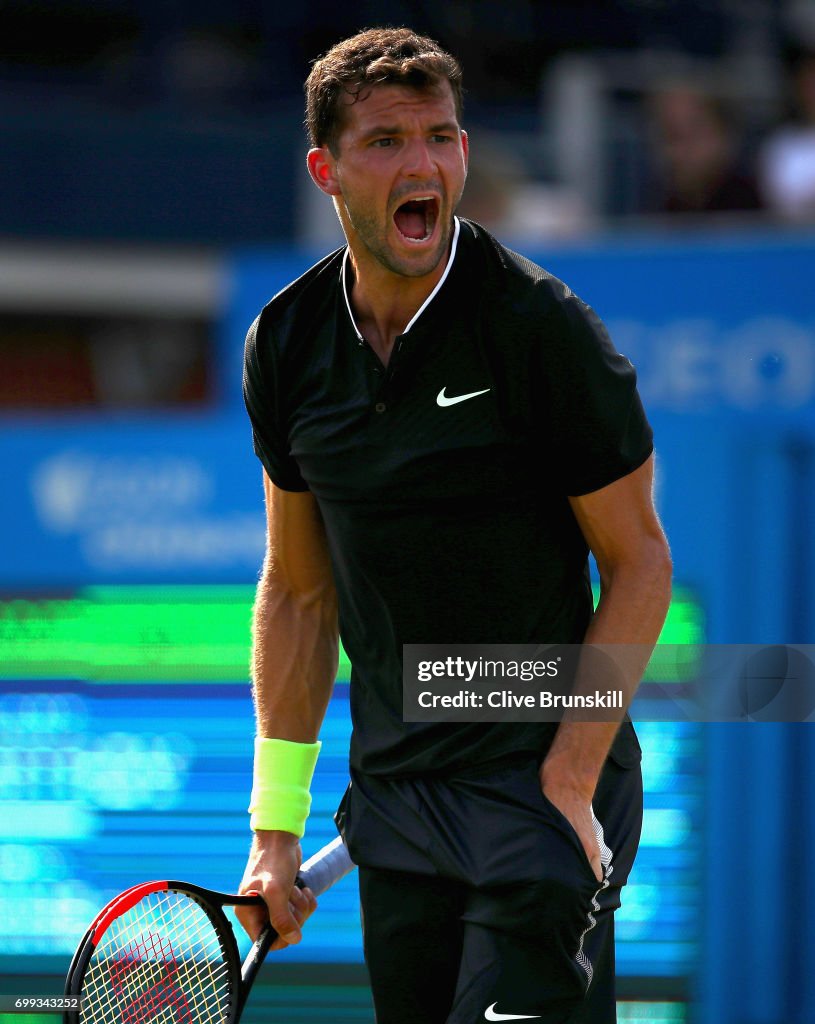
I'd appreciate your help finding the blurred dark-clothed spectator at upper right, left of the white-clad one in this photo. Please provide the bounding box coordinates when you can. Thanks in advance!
[648,84,764,213]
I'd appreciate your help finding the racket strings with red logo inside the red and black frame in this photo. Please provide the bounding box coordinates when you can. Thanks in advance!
[80,892,231,1024]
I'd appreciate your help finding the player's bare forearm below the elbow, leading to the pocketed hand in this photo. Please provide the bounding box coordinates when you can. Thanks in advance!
[542,544,671,800]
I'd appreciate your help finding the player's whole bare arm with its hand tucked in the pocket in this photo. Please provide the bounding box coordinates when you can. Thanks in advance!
[541,455,672,881]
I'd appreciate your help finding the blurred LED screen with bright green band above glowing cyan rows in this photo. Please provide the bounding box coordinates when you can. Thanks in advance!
[0,586,704,991]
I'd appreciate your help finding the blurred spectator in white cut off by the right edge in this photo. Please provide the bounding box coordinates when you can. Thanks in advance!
[761,45,815,220]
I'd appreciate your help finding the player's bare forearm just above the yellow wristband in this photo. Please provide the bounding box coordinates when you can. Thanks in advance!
[252,558,339,743]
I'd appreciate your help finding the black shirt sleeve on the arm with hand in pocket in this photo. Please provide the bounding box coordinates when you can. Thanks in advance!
[542,282,653,496]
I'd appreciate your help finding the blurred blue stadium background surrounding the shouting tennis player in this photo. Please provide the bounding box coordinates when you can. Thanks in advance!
[0,0,815,1024]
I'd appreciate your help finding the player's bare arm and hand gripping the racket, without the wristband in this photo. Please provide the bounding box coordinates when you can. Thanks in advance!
[239,472,339,948]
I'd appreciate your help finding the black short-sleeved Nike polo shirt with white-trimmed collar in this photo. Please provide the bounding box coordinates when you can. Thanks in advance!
[244,220,651,775]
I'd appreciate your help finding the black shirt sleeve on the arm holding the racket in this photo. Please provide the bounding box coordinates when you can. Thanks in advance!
[244,313,308,490]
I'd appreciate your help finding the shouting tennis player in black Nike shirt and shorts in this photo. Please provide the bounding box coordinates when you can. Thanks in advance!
[234,29,671,1024]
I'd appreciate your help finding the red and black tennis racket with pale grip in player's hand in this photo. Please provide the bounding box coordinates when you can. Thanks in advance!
[65,837,354,1024]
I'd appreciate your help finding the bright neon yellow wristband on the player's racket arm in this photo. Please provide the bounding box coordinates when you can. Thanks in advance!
[249,736,323,838]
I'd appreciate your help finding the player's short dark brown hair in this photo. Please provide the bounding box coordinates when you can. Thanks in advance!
[305,28,463,153]
